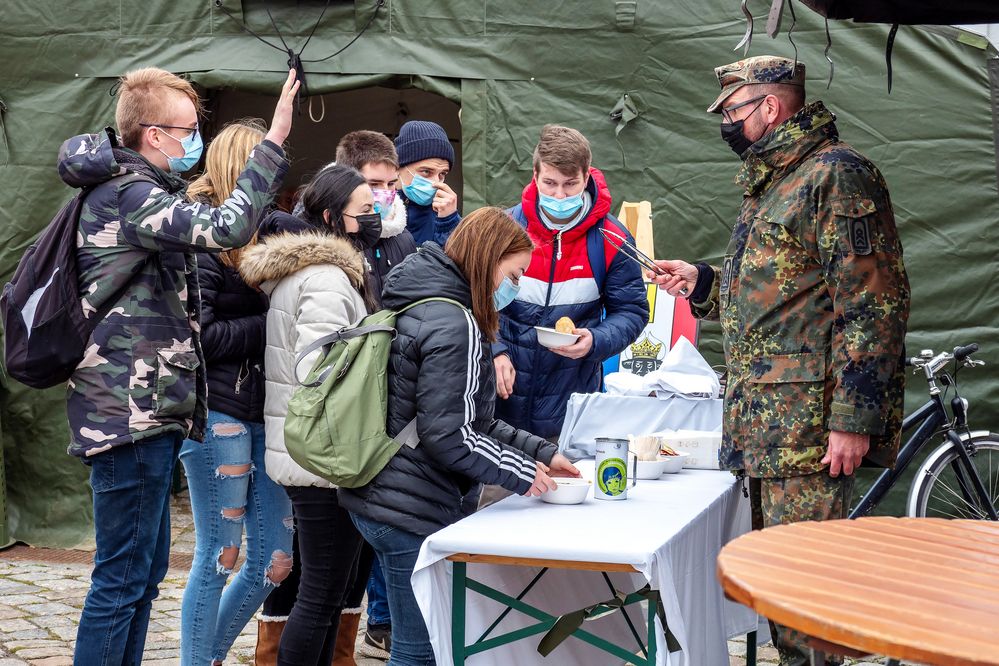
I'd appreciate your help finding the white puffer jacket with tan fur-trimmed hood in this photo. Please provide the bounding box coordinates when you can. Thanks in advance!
[239,233,367,488]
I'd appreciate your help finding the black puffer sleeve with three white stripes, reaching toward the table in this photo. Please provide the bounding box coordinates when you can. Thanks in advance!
[416,305,536,493]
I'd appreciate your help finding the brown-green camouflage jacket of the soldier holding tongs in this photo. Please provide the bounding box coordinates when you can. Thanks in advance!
[693,102,909,477]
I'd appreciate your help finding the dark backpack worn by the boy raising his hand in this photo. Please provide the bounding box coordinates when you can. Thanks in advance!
[0,179,139,388]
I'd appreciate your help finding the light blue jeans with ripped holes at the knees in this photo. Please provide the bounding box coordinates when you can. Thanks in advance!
[180,411,294,666]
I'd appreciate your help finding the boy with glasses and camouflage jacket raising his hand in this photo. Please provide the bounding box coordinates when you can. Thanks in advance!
[59,68,297,665]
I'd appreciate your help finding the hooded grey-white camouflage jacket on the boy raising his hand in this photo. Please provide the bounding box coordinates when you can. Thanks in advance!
[59,133,288,456]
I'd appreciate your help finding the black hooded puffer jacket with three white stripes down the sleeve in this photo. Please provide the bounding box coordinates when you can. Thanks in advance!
[339,243,557,536]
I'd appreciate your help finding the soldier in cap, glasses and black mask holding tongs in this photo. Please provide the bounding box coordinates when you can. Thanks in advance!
[656,56,909,664]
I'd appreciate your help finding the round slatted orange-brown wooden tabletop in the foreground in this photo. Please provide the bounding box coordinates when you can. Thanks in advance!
[718,518,999,665]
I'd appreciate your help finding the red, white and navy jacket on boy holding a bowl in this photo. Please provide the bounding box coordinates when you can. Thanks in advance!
[493,168,649,437]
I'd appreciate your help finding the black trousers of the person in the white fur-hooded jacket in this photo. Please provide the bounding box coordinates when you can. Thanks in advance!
[278,487,363,666]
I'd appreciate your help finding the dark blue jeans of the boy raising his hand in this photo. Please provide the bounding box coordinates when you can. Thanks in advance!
[73,433,181,666]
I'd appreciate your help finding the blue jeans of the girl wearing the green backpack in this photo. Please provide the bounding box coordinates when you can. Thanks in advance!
[350,513,437,666]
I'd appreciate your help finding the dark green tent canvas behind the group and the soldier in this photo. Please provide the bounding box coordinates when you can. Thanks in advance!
[0,0,999,546]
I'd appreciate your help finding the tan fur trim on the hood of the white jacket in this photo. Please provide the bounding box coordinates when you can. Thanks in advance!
[239,232,364,290]
